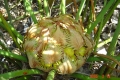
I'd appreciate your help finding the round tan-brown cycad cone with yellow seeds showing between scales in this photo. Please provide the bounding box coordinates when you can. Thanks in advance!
[23,15,93,74]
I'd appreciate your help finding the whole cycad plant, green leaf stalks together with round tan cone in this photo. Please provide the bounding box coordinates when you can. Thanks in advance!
[0,0,120,80]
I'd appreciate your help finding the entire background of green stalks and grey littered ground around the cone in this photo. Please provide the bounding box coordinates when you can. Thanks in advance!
[0,0,120,80]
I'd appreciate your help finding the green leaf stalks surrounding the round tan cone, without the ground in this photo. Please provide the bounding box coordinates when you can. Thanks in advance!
[0,0,120,80]
